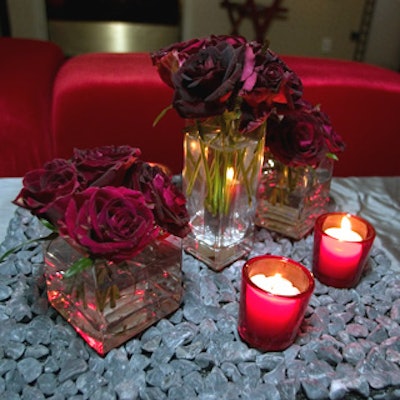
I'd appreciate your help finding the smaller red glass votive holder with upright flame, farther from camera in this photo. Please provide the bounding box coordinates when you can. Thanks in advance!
[312,212,376,288]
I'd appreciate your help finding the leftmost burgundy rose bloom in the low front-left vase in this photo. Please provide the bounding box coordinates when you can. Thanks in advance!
[13,159,79,225]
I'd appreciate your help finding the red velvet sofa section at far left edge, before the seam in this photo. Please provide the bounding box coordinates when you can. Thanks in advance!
[0,37,64,177]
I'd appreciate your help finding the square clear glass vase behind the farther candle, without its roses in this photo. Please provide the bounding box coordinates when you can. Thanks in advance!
[256,151,333,240]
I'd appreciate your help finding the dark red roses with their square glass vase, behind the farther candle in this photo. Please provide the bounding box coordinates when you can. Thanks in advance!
[256,99,344,239]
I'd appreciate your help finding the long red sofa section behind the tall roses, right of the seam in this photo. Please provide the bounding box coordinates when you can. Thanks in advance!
[52,53,400,176]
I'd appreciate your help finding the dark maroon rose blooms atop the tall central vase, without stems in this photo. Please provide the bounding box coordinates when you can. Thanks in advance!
[152,35,303,133]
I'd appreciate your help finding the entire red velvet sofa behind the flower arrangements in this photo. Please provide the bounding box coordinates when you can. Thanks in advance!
[0,38,400,176]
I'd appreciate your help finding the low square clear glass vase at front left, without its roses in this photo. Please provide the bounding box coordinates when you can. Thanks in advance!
[45,235,182,355]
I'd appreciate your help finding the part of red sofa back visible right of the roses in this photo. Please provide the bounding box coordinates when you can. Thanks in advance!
[282,56,400,176]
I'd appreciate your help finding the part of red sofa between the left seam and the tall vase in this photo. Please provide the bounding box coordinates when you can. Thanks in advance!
[52,53,184,173]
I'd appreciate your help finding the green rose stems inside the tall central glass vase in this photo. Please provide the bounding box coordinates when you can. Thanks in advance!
[185,113,264,216]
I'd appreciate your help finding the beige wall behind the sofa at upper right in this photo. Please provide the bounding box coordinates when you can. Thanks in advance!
[182,0,400,69]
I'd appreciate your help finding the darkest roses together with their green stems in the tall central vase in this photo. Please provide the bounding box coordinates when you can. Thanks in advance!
[152,35,302,219]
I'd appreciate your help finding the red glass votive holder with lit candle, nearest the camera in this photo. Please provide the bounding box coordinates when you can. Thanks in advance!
[238,255,314,351]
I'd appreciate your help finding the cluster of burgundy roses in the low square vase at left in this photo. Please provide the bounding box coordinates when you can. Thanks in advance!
[3,146,189,309]
